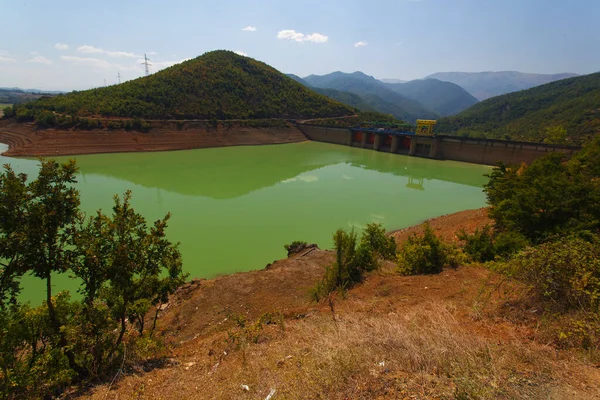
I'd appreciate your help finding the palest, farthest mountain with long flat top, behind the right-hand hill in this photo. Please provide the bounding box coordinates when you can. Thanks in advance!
[425,71,577,100]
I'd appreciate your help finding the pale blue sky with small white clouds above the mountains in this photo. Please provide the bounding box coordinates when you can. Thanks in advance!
[0,0,600,90]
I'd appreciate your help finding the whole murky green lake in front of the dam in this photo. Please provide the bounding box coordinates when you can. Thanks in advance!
[0,142,490,302]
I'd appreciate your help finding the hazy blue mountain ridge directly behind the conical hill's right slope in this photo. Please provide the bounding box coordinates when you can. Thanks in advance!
[303,72,439,122]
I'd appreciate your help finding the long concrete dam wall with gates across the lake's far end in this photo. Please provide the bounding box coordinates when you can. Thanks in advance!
[297,124,581,165]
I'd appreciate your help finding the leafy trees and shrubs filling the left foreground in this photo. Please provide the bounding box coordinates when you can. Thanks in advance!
[0,160,184,398]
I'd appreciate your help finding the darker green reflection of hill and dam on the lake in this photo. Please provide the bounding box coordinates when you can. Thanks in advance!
[54,143,490,199]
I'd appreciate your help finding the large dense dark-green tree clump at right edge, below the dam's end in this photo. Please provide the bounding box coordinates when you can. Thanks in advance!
[485,139,600,243]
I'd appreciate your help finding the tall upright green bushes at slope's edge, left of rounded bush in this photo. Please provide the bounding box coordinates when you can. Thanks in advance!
[310,223,396,301]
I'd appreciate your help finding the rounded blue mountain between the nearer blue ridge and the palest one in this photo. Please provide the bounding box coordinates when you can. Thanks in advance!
[387,79,478,117]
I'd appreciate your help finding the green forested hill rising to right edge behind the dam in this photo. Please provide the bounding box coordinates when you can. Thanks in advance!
[436,72,600,144]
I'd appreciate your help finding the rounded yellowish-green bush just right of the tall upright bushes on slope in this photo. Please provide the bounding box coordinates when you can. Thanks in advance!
[398,223,461,275]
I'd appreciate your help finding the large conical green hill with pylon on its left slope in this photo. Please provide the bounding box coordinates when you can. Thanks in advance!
[16,50,355,119]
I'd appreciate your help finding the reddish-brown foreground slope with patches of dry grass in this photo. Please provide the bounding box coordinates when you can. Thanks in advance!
[71,209,600,400]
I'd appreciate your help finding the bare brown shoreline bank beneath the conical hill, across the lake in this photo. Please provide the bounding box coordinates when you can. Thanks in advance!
[0,121,306,157]
